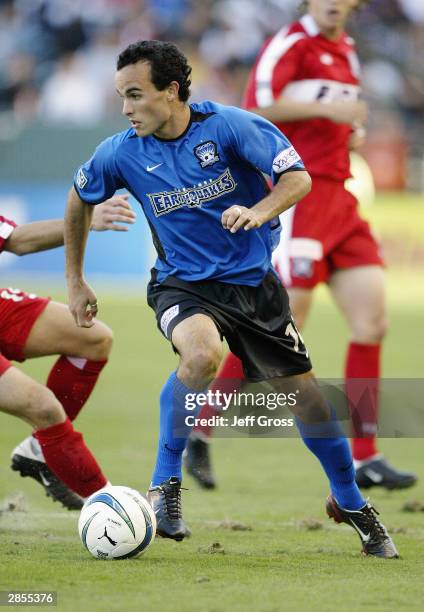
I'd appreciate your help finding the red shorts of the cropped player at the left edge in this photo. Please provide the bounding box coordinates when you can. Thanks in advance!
[0,288,50,375]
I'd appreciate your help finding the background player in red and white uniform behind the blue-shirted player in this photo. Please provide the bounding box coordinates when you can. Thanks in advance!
[186,0,416,489]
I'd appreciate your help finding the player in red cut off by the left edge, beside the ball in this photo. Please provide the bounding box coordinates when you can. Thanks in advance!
[0,196,135,509]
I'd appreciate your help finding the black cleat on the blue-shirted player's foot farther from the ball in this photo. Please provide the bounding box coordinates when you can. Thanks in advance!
[326,495,399,559]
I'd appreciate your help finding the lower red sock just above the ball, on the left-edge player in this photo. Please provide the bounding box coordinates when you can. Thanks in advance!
[33,419,107,497]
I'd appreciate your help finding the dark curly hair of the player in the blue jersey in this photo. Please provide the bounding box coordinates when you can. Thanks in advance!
[116,40,191,102]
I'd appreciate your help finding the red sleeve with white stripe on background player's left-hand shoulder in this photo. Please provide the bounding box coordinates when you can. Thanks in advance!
[243,29,305,109]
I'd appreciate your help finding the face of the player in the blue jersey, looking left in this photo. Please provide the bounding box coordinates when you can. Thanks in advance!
[115,61,178,136]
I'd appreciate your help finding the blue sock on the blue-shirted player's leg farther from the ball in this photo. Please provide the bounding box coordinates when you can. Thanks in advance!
[296,411,366,510]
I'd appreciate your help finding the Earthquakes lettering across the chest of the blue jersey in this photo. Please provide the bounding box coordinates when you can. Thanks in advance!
[147,168,237,217]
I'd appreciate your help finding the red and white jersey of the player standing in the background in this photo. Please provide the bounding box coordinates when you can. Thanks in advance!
[244,15,360,181]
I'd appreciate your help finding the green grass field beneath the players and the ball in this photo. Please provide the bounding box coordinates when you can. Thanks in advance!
[0,194,424,612]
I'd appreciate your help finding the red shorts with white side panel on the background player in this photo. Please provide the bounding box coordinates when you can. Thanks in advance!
[273,178,384,289]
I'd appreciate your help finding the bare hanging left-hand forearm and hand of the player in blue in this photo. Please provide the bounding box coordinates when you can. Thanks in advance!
[65,187,97,327]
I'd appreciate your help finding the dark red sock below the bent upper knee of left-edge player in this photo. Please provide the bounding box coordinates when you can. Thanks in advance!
[47,355,107,421]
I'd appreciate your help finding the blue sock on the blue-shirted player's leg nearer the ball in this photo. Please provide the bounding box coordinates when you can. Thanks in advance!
[152,372,198,486]
